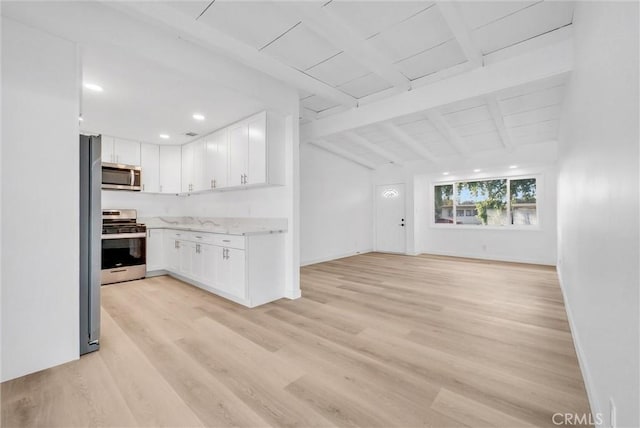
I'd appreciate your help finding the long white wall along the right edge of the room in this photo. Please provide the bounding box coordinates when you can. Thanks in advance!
[558,2,640,427]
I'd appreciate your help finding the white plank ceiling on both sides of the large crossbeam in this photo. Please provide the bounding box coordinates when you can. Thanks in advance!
[170,0,573,168]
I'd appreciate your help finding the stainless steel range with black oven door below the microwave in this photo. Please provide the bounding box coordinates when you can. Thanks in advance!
[101,210,147,285]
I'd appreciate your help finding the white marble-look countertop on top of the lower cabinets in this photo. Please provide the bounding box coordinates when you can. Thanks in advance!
[138,217,287,236]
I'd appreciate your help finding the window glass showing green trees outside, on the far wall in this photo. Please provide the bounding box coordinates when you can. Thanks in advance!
[434,178,538,226]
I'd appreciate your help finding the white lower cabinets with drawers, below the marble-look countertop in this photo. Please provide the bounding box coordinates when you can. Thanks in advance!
[147,229,284,307]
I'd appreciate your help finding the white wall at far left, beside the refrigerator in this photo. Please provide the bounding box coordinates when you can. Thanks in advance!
[1,18,80,380]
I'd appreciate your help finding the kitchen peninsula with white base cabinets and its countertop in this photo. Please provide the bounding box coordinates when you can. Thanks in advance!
[145,217,287,307]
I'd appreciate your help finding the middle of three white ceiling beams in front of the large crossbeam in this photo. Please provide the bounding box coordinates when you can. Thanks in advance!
[282,2,411,91]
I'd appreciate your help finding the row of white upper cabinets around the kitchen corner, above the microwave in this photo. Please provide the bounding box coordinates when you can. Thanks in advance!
[102,112,285,194]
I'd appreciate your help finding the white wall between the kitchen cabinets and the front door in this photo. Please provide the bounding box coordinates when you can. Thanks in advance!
[300,144,373,265]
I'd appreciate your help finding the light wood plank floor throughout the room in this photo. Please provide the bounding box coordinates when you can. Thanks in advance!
[2,253,589,427]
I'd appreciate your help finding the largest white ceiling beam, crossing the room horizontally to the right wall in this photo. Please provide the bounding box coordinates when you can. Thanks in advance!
[300,40,573,140]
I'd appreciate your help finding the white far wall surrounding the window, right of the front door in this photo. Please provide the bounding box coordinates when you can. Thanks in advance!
[373,141,557,265]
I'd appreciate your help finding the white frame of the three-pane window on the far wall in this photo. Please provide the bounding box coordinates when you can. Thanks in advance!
[429,174,544,231]
